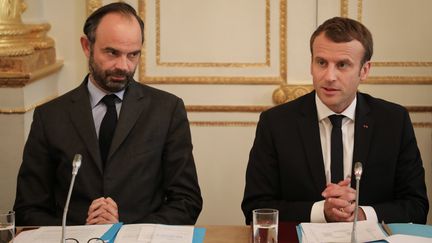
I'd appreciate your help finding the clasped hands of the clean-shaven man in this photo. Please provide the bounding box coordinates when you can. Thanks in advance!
[322,178,356,222]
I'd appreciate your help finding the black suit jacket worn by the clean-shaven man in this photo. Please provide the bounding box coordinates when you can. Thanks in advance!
[242,92,429,223]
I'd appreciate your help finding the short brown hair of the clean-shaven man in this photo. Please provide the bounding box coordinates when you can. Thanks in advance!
[310,17,373,64]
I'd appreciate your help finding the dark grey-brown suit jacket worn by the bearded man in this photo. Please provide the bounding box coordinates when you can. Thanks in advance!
[14,78,202,225]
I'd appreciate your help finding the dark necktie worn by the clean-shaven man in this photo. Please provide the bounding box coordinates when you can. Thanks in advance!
[329,115,345,183]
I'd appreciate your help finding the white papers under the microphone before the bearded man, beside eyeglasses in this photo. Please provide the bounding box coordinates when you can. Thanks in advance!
[14,224,112,243]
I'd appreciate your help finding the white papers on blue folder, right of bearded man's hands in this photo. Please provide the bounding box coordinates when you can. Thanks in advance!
[115,224,194,243]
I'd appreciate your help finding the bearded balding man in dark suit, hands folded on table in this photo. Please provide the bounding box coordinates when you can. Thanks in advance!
[14,3,202,225]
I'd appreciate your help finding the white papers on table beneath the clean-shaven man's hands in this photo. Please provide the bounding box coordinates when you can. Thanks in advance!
[300,221,386,243]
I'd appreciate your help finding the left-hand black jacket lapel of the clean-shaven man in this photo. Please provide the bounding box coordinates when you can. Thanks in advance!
[298,92,326,193]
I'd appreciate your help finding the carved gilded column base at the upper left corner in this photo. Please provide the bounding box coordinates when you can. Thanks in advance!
[0,0,62,87]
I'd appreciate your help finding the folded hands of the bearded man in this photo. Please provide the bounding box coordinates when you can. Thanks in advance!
[86,197,119,224]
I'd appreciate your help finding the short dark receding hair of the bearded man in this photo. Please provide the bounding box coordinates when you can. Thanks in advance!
[83,2,144,44]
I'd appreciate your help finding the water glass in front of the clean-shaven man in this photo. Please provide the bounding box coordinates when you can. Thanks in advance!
[252,208,279,243]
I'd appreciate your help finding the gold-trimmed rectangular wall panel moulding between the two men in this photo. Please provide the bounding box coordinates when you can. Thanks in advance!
[138,0,287,84]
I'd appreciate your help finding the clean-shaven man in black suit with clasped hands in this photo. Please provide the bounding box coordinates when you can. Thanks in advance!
[242,17,429,224]
